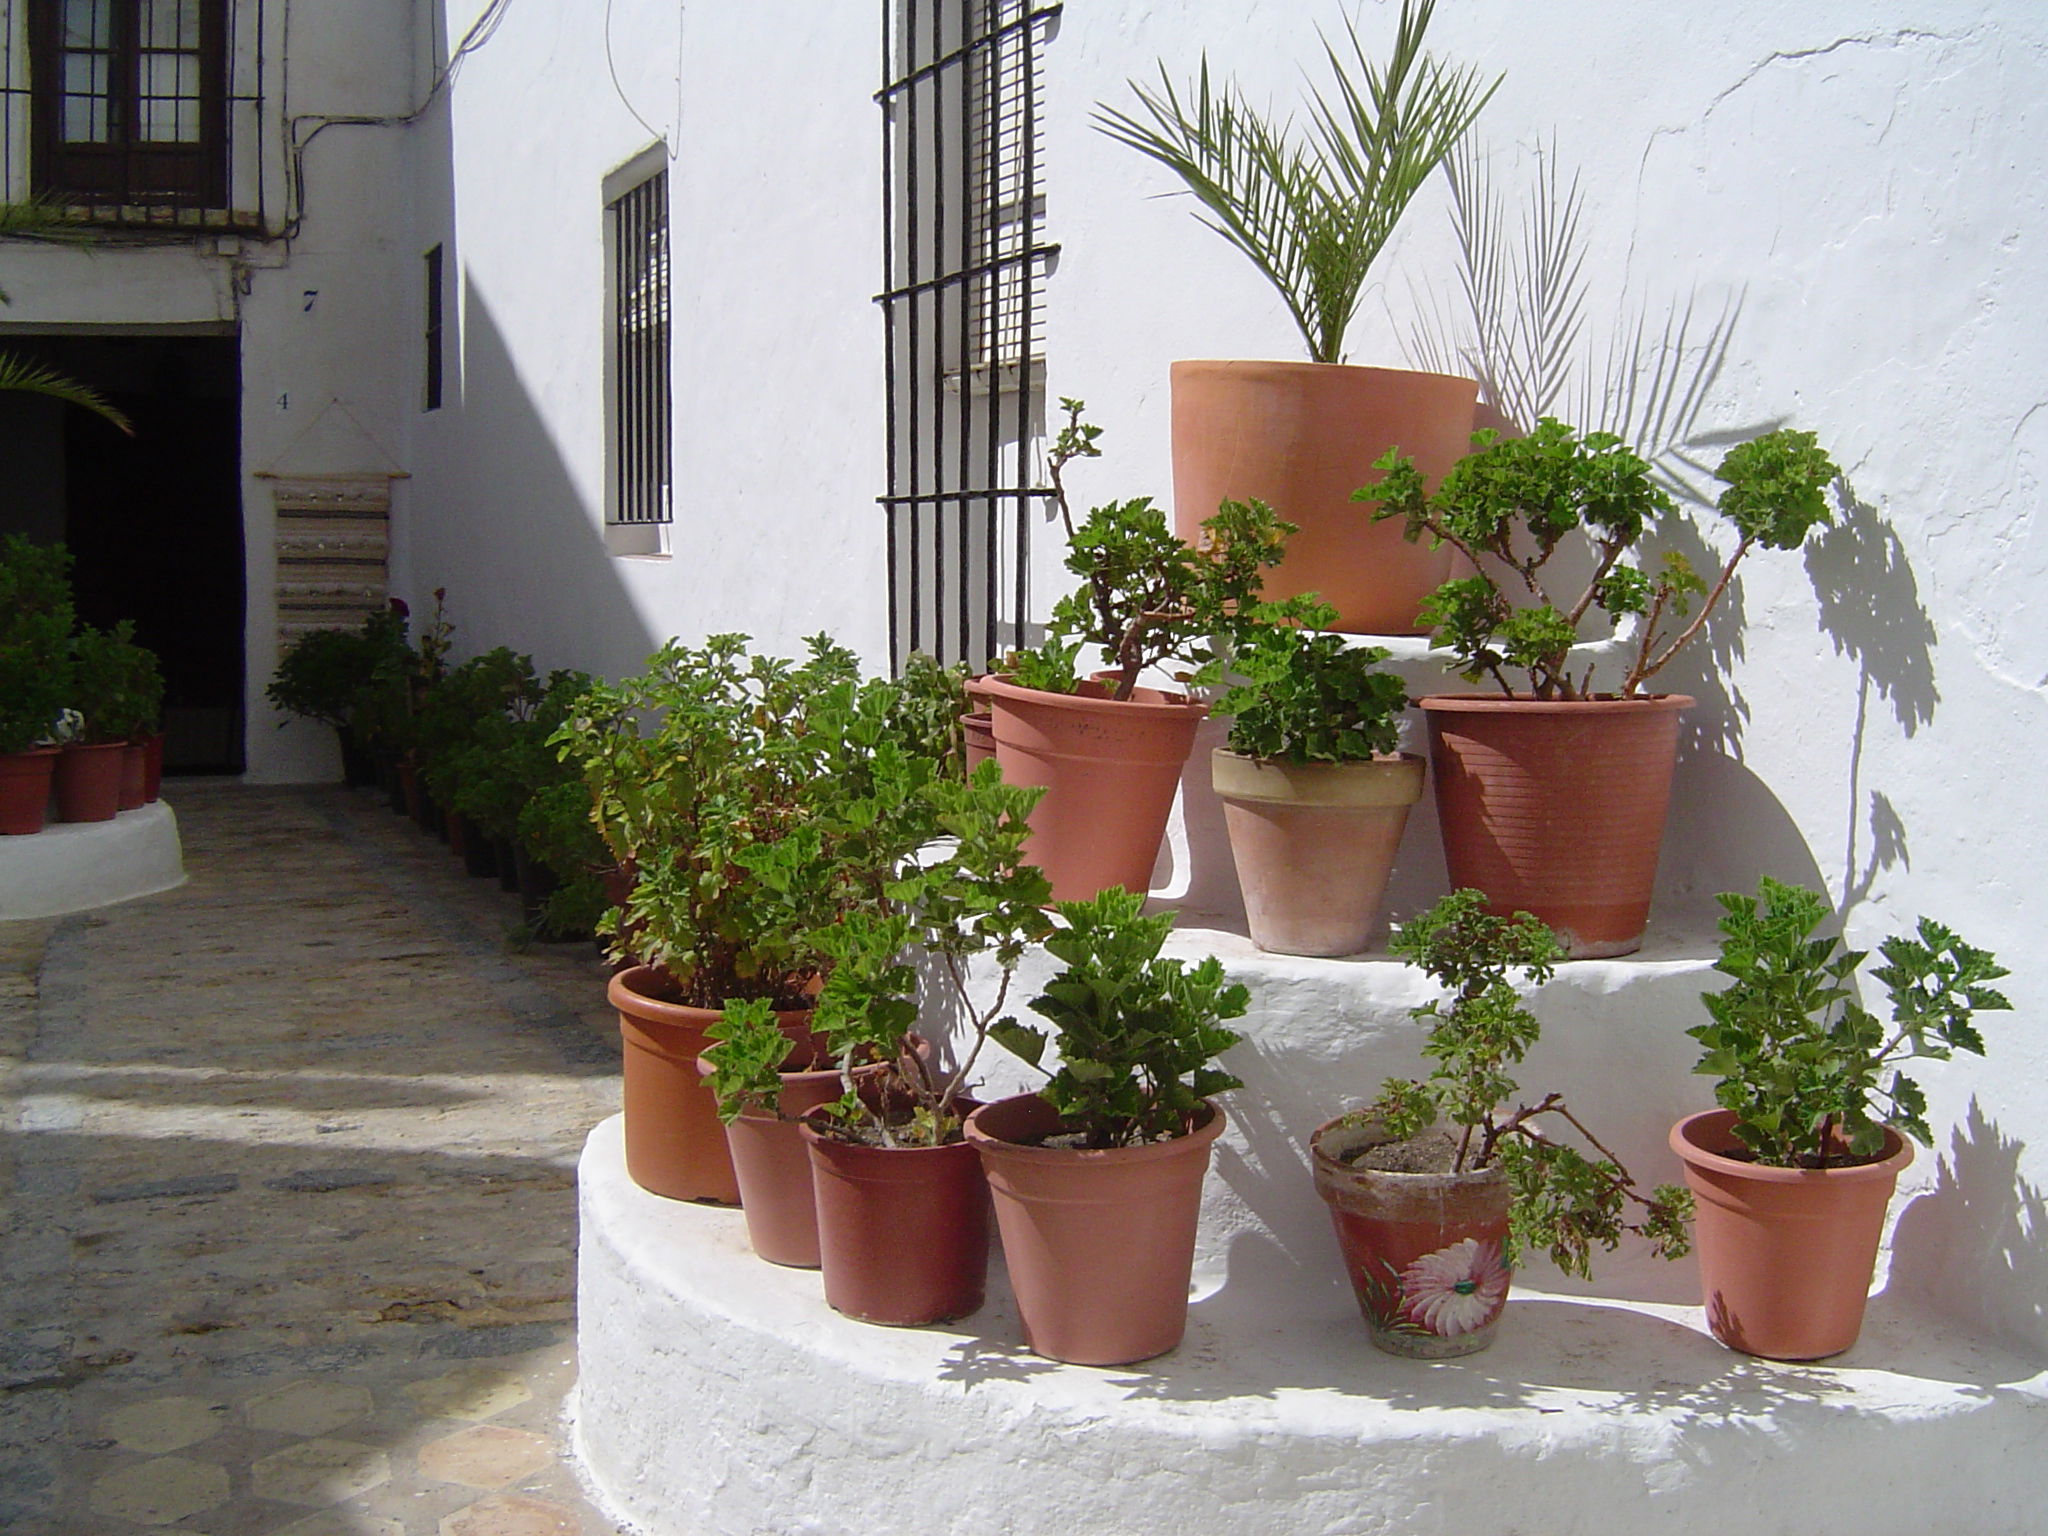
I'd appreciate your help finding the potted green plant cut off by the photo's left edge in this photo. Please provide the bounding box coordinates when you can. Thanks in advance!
[0,532,74,836]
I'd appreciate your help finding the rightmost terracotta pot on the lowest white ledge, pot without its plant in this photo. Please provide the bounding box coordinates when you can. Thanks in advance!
[1671,1110,1913,1360]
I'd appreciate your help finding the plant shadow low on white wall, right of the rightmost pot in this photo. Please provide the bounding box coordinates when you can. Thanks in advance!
[1886,1098,2048,1356]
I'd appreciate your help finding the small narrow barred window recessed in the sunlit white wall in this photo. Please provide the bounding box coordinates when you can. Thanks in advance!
[604,170,674,536]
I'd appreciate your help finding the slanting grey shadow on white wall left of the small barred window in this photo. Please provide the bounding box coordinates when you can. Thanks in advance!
[412,287,657,678]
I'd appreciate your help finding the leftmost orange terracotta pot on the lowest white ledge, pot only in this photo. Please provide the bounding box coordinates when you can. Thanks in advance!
[604,965,811,1206]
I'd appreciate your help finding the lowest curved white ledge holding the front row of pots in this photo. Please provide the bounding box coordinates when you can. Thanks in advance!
[575,1118,2048,1536]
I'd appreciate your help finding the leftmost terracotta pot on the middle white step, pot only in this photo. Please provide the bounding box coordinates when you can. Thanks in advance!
[983,678,1208,901]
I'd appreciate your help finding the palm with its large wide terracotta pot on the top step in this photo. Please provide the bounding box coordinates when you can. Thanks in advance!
[1096,0,1499,635]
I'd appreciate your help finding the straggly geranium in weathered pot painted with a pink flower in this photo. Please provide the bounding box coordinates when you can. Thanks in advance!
[1309,891,1692,1360]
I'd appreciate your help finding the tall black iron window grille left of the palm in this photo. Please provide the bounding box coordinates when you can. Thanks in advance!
[877,0,1061,668]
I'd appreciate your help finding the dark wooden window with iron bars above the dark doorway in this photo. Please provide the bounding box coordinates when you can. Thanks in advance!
[0,0,268,231]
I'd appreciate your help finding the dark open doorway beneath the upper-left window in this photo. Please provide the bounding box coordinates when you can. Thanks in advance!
[0,334,244,774]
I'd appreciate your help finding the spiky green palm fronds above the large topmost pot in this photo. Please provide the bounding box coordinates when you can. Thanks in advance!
[1096,0,1499,362]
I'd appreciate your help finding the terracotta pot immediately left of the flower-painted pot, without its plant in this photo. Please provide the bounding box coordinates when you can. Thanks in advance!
[967,1094,1223,1366]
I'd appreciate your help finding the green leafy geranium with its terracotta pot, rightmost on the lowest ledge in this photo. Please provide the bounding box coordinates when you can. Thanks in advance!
[1671,877,2011,1360]
